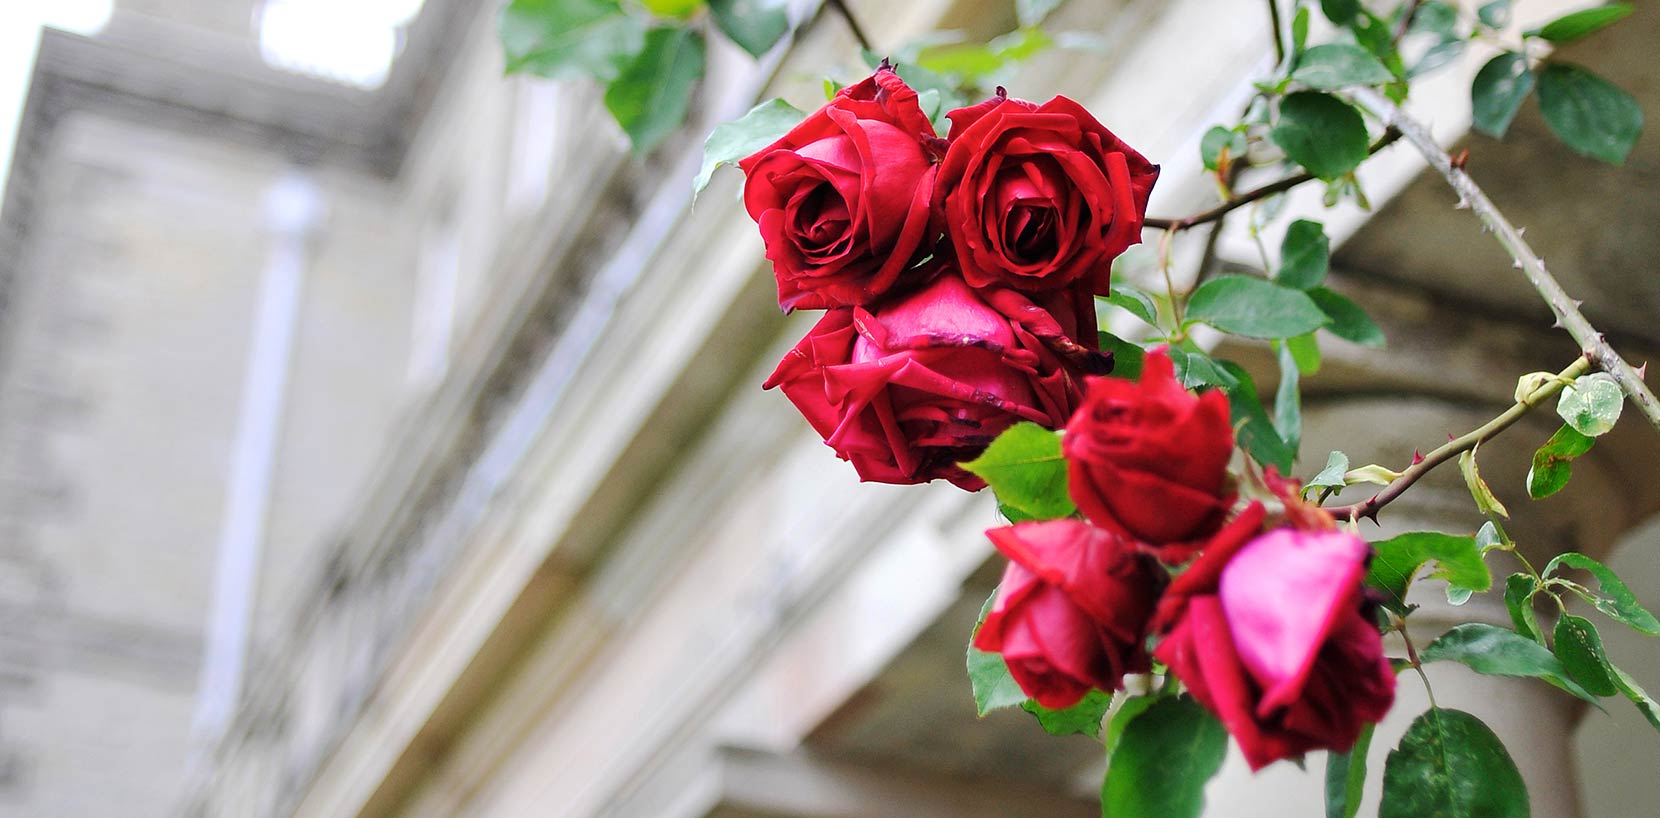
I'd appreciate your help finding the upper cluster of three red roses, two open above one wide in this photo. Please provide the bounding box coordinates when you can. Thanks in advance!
[739,66,1159,489]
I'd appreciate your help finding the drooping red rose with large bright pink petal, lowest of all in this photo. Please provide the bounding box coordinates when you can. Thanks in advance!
[1154,527,1394,770]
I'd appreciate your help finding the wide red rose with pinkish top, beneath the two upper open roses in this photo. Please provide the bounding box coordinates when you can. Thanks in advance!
[765,270,1096,491]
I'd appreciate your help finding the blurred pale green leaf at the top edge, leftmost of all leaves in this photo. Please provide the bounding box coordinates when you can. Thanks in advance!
[498,0,646,81]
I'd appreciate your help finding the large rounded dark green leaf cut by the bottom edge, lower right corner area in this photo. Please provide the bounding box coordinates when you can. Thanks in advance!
[1378,707,1529,818]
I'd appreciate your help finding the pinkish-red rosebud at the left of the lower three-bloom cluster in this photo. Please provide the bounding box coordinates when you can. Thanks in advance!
[974,519,1164,708]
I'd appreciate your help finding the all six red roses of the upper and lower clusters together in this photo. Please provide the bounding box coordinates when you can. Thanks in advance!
[739,66,1394,767]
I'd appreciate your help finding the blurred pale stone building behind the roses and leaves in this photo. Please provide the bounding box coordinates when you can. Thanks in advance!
[0,0,1660,818]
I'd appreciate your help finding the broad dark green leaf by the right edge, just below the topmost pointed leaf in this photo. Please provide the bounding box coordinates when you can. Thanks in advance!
[1539,63,1643,164]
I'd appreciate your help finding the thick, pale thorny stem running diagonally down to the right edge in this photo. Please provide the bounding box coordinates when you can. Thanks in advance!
[1348,88,1660,430]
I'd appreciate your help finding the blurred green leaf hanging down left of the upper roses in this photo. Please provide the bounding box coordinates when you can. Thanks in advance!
[606,28,704,154]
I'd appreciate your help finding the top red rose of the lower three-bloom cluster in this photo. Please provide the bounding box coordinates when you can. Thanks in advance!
[1062,350,1233,562]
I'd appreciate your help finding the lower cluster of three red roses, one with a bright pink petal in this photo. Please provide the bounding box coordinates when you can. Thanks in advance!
[974,352,1394,768]
